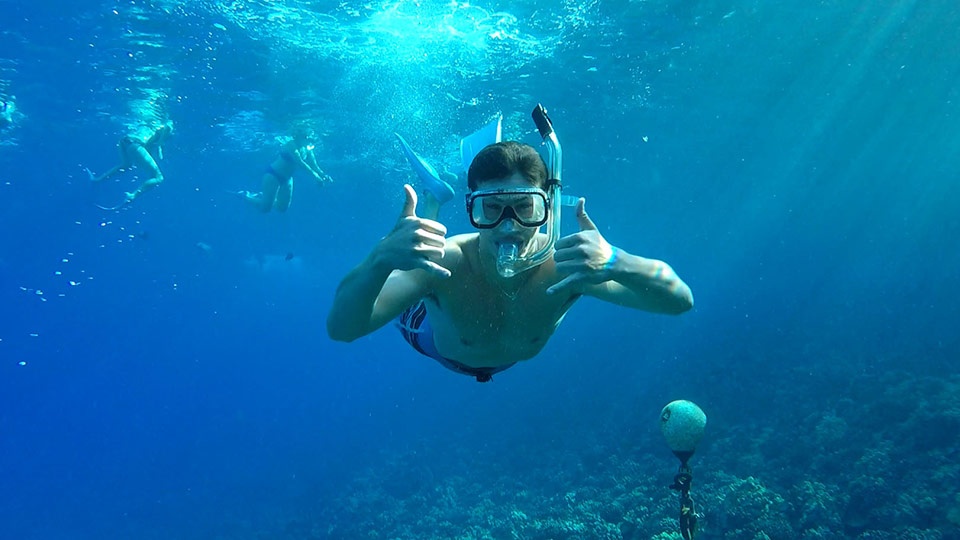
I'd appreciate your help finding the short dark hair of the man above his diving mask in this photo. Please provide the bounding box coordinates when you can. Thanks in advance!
[467,141,547,191]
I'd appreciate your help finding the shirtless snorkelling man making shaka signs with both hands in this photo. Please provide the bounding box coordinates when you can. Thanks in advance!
[327,112,693,382]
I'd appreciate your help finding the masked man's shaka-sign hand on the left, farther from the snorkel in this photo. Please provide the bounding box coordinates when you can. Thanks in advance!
[377,184,450,278]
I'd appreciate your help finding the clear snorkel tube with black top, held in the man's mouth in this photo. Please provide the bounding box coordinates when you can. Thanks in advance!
[497,103,563,277]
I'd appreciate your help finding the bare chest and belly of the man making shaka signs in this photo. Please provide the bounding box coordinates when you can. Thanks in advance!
[426,234,577,367]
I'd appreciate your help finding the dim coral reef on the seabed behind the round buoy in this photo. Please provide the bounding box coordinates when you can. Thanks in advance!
[260,352,960,540]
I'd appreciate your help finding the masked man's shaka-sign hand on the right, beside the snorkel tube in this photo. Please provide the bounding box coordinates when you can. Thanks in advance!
[547,198,617,294]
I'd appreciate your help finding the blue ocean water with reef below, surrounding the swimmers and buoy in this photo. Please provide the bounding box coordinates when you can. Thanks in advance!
[0,0,960,539]
